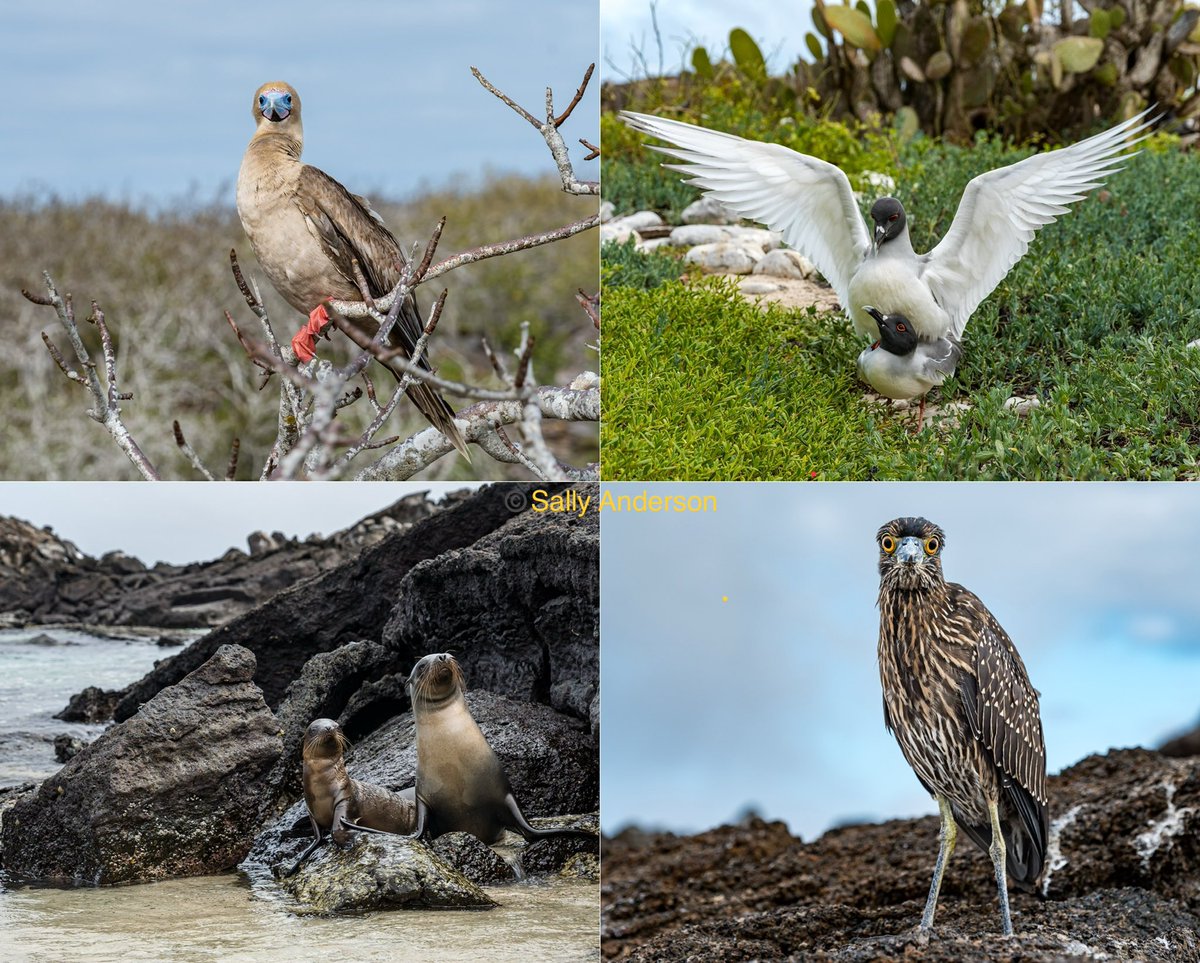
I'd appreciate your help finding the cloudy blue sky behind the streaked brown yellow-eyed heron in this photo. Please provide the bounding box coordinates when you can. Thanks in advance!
[601,483,1200,838]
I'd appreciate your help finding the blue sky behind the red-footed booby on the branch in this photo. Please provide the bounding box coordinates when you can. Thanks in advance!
[0,0,599,204]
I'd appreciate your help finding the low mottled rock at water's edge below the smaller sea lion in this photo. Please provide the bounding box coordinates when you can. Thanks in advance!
[282,833,496,914]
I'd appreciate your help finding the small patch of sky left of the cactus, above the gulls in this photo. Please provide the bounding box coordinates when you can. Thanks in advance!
[600,0,812,80]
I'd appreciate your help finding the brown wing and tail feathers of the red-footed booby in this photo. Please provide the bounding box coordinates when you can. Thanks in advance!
[296,165,470,461]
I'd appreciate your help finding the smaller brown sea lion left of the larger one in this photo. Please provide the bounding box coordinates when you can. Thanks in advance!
[284,719,416,877]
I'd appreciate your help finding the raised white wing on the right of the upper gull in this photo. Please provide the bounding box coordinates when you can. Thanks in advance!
[922,110,1151,337]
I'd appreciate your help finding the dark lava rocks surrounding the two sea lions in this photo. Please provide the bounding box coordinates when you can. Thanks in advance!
[0,485,599,911]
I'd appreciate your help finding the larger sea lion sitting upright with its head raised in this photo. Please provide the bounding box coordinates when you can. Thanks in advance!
[407,652,595,843]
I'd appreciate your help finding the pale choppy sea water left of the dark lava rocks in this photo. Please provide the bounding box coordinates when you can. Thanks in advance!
[0,626,171,788]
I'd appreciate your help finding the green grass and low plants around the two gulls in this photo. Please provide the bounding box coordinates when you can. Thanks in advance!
[601,140,1200,480]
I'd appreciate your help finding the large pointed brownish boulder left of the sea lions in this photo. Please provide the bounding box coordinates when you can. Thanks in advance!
[0,646,282,884]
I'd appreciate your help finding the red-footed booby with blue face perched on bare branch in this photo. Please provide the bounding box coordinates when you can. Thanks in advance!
[238,82,470,461]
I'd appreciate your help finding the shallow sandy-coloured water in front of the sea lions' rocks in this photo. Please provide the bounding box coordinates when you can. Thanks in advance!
[0,874,600,963]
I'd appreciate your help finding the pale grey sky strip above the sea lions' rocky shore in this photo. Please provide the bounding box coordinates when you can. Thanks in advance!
[0,482,480,564]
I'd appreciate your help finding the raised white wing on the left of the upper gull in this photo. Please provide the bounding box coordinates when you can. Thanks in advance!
[622,110,871,304]
